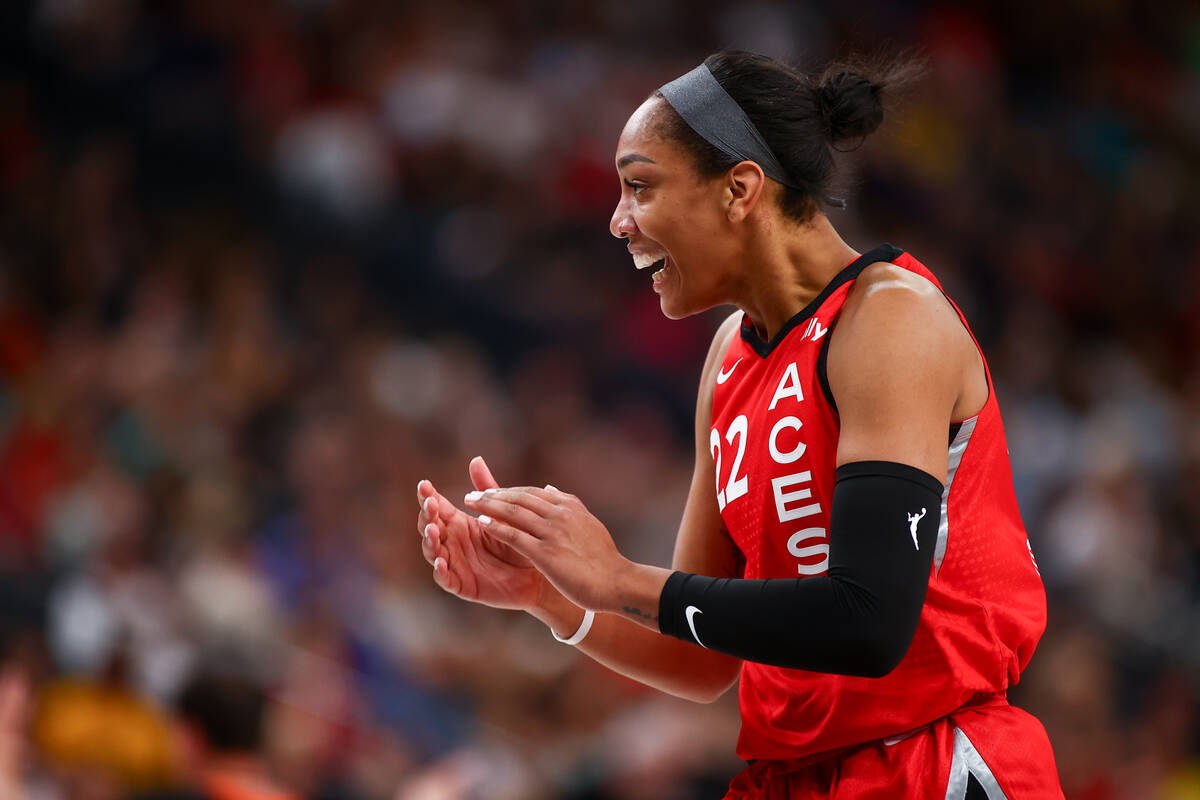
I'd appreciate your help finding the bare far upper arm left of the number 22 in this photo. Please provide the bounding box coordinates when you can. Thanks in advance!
[672,312,742,577]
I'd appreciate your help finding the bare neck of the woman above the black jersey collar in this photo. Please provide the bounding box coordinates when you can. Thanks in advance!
[734,212,858,342]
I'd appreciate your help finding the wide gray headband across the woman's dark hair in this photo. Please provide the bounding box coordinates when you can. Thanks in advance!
[659,64,799,188]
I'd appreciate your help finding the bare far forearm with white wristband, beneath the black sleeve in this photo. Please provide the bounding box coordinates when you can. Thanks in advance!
[529,578,742,703]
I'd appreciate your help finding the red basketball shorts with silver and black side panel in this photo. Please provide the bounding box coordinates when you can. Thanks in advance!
[725,697,1063,800]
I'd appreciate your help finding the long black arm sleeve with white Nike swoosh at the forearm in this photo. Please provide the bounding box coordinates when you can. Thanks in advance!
[659,461,942,678]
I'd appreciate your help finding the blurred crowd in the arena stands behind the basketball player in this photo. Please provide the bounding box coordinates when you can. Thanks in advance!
[0,0,1200,800]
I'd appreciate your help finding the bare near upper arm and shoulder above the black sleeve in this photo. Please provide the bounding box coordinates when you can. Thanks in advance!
[827,264,978,483]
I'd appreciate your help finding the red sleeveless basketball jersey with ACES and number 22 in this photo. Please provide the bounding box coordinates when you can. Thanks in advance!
[709,246,1046,759]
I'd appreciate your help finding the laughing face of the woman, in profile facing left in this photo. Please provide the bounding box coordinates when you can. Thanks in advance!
[608,97,738,319]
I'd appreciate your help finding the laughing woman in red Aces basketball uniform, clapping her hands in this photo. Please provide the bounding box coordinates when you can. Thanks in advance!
[418,53,1062,800]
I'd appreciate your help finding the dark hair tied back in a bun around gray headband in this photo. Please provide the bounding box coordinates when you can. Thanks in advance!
[655,50,924,221]
